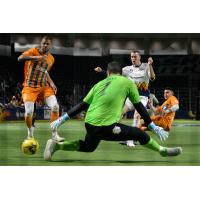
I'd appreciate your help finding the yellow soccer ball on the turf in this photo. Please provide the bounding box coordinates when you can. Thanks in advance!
[21,139,39,155]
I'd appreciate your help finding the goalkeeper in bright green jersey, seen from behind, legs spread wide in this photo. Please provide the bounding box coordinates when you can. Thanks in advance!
[44,62,182,160]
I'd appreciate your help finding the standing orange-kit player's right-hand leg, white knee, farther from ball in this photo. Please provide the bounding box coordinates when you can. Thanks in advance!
[45,95,64,141]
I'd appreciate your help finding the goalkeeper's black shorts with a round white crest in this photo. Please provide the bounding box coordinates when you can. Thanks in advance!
[79,123,150,152]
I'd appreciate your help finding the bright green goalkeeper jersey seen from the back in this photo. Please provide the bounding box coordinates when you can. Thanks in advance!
[83,75,140,126]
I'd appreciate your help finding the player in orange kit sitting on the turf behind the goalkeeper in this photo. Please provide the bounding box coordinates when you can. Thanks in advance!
[142,87,179,131]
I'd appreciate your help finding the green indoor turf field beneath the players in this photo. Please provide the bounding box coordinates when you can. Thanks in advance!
[0,120,200,166]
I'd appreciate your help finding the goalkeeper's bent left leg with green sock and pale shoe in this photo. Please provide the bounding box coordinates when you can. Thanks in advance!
[44,124,101,160]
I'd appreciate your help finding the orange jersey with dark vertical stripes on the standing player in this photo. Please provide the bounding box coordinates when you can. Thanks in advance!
[23,48,54,88]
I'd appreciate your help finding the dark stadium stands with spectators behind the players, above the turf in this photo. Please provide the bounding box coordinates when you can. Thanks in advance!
[0,33,200,119]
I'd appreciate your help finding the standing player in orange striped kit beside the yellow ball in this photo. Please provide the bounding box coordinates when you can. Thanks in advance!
[18,36,64,141]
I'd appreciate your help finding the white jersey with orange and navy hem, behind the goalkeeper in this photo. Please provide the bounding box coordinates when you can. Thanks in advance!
[122,63,150,97]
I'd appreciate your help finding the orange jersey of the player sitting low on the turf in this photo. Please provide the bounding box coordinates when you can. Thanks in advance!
[157,96,179,128]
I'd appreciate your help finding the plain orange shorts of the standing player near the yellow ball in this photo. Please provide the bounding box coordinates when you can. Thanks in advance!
[22,86,55,103]
